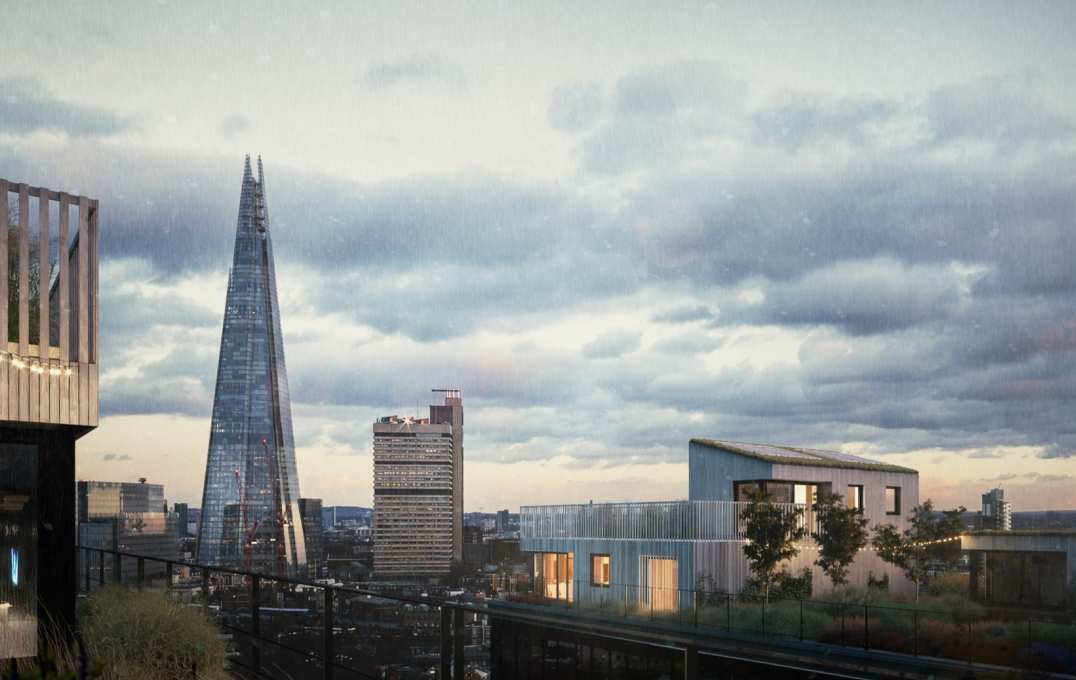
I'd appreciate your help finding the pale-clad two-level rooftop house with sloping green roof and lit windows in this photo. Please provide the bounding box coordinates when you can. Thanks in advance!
[520,439,919,610]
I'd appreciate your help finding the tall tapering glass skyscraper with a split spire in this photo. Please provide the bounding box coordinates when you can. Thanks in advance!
[197,156,307,575]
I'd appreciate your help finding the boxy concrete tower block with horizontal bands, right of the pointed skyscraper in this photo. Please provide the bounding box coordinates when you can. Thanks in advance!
[373,389,464,578]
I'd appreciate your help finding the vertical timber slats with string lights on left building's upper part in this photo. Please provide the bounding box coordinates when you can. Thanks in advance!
[0,179,100,427]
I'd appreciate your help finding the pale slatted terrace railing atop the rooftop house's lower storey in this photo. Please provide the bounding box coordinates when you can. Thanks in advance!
[520,500,811,541]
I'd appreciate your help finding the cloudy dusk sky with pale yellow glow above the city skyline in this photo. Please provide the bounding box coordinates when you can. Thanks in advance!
[0,2,1076,511]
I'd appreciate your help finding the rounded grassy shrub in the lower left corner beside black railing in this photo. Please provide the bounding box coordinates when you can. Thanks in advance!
[80,587,228,680]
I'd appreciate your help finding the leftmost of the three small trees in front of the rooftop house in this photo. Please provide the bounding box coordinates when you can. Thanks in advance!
[740,492,807,603]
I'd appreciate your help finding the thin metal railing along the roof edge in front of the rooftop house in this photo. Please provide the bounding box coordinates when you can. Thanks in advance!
[506,580,1076,674]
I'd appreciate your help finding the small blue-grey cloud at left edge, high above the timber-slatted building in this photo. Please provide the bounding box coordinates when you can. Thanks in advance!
[0,77,133,138]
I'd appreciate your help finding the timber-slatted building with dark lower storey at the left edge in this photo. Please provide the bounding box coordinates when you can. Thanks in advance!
[0,179,98,658]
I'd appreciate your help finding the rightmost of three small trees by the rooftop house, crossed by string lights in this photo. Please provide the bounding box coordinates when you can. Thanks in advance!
[870,499,967,603]
